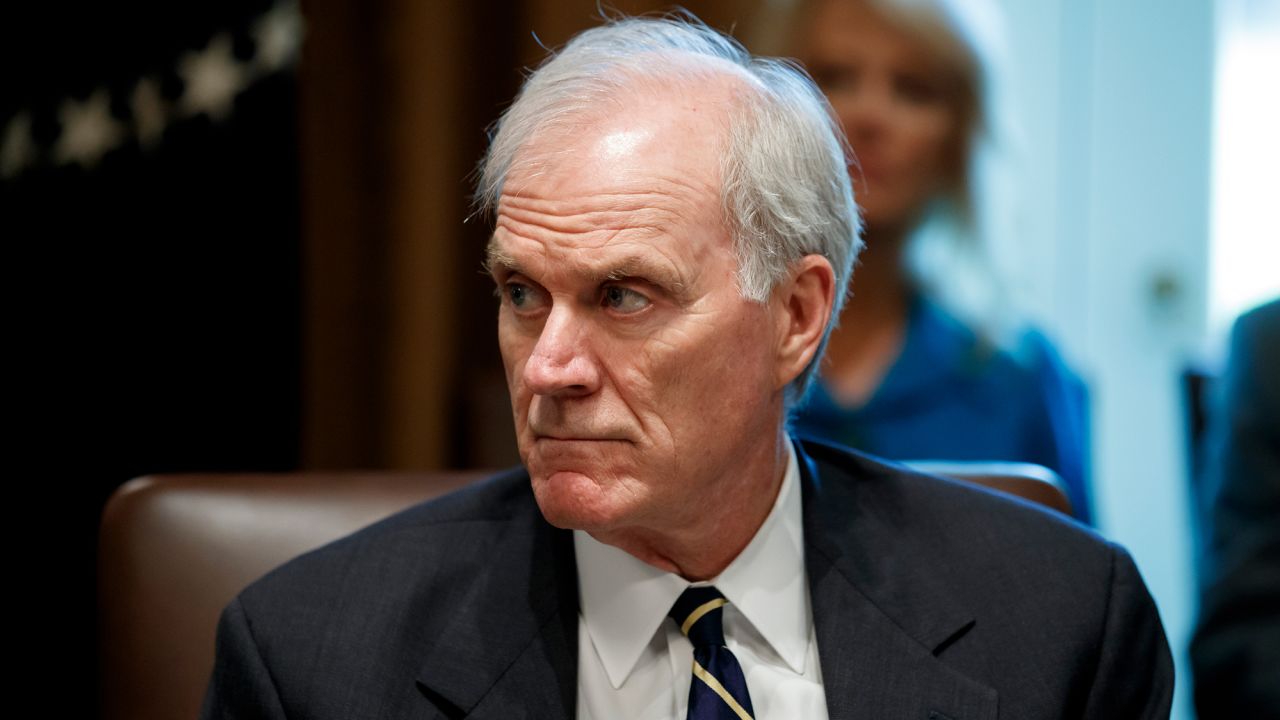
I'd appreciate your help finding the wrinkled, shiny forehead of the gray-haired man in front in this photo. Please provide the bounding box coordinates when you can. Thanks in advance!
[490,74,747,272]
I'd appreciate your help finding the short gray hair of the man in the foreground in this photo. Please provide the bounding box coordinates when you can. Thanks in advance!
[476,14,861,407]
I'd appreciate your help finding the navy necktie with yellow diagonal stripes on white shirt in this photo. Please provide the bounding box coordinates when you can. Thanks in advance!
[668,587,754,720]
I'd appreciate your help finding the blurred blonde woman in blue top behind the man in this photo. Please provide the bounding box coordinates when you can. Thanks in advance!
[792,0,1092,521]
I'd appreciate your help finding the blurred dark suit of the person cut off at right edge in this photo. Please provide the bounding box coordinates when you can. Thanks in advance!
[1190,300,1280,720]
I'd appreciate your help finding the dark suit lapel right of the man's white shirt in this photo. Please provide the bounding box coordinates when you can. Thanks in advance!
[799,438,997,720]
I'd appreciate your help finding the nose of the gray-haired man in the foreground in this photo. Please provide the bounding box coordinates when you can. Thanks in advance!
[524,305,600,397]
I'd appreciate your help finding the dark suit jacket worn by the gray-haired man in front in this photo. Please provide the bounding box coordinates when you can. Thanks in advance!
[204,443,1172,720]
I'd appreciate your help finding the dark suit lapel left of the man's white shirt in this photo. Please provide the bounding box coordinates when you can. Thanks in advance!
[419,497,577,719]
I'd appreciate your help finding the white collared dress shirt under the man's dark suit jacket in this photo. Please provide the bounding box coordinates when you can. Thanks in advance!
[573,443,827,720]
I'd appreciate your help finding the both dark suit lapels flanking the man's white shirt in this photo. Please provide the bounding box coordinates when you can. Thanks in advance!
[419,447,997,720]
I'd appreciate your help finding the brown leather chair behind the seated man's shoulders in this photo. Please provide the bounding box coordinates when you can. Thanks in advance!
[99,462,1070,720]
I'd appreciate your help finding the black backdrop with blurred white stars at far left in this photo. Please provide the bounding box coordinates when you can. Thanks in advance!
[0,0,301,716]
